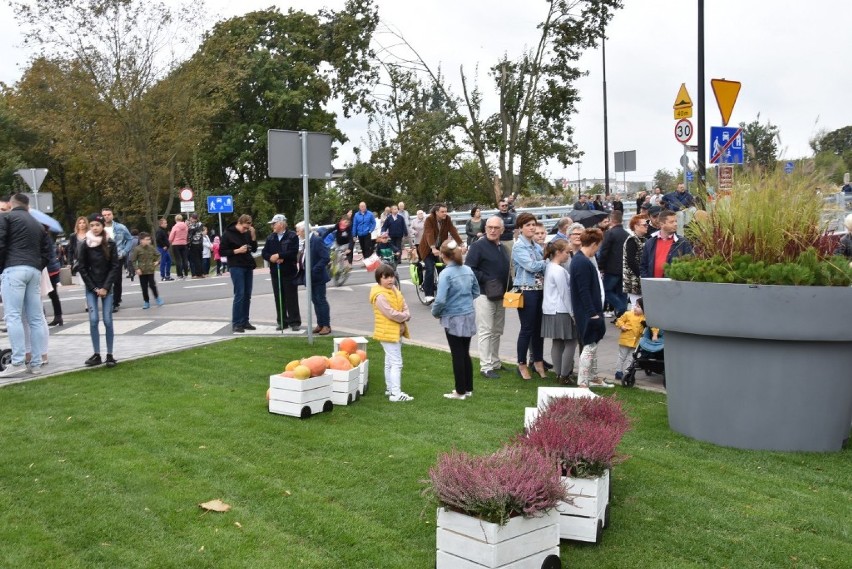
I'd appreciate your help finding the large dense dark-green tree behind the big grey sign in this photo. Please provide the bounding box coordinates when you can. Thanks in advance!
[188,0,378,223]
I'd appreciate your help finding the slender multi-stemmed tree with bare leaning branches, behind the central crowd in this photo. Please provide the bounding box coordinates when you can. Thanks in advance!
[376,0,622,197]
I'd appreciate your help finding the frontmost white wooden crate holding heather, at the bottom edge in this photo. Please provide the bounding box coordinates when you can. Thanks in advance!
[435,508,562,569]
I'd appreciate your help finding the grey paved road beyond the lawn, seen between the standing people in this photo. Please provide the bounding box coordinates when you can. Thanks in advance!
[0,264,662,389]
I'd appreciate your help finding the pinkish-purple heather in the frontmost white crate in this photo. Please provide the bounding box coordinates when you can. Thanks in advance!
[425,446,568,525]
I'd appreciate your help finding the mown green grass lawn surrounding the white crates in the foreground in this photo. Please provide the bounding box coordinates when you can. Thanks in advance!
[0,338,852,569]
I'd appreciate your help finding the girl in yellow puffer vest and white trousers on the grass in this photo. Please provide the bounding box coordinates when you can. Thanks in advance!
[370,264,414,403]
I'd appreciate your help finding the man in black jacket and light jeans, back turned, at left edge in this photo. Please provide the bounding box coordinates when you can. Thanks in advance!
[0,194,50,377]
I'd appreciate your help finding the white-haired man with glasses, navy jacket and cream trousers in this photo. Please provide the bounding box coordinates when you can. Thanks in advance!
[464,215,509,379]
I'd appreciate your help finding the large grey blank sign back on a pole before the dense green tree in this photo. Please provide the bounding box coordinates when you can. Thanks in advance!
[267,129,334,180]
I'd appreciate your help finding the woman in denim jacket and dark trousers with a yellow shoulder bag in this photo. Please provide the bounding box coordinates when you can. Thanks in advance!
[512,212,547,380]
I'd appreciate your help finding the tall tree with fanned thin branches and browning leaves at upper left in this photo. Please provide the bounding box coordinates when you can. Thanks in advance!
[12,0,208,224]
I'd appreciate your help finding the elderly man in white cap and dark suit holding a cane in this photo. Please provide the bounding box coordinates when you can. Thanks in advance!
[260,213,302,333]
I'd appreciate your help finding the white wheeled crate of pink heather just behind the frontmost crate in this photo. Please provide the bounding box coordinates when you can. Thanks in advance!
[556,470,610,543]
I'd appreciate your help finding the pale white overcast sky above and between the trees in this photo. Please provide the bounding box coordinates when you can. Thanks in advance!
[0,0,852,181]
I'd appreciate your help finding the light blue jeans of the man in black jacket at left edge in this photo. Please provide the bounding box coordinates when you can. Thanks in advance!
[0,265,47,367]
